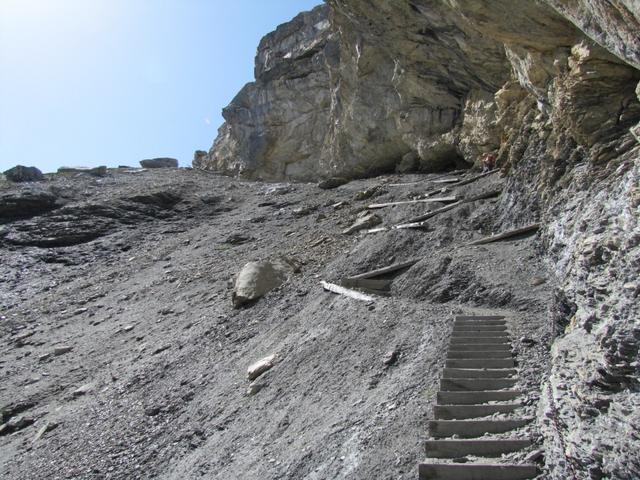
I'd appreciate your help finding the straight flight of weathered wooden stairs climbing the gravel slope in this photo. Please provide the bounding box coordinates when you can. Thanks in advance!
[419,316,539,480]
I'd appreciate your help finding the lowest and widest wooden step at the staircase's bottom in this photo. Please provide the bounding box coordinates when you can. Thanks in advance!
[418,463,538,480]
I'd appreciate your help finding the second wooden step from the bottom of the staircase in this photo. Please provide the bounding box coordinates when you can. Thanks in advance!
[425,438,531,458]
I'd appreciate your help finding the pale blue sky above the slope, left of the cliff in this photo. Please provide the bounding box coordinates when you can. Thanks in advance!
[0,0,321,172]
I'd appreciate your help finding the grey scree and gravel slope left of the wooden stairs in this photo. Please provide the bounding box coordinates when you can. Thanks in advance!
[0,169,551,479]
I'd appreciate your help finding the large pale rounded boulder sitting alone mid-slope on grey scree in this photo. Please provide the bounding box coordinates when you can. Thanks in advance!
[232,262,288,308]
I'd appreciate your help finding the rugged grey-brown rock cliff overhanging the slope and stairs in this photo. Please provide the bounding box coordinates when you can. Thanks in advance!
[194,0,640,479]
